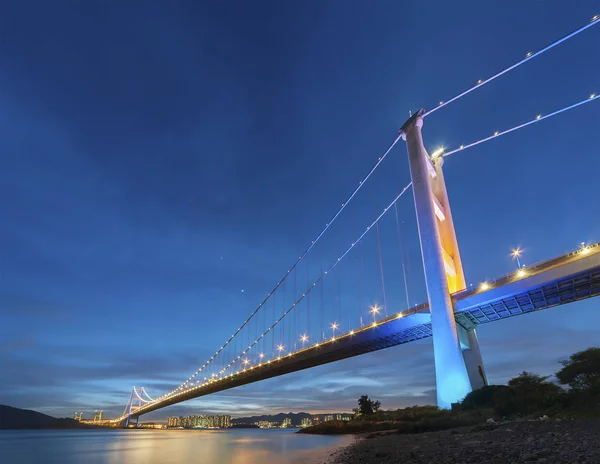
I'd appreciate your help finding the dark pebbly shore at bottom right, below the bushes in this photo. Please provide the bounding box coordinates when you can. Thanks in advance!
[329,419,600,464]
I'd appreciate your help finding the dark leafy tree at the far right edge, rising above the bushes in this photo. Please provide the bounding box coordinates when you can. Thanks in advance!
[556,348,600,395]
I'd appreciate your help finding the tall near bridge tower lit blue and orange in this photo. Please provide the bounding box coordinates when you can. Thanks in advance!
[400,110,487,408]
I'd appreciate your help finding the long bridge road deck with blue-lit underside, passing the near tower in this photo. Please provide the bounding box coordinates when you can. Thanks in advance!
[130,245,600,416]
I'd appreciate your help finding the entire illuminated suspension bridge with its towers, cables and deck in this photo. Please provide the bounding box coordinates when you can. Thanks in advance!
[86,16,600,426]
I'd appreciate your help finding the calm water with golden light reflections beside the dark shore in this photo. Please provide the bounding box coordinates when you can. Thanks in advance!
[0,429,351,464]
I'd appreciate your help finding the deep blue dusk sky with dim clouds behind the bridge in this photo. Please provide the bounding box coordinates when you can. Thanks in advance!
[0,0,600,418]
